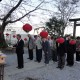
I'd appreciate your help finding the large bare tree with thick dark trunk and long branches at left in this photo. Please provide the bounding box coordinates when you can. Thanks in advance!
[0,0,44,46]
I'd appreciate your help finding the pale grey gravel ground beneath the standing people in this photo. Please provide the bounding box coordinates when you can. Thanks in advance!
[0,49,80,80]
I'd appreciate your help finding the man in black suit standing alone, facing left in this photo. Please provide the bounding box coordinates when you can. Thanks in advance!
[14,34,24,69]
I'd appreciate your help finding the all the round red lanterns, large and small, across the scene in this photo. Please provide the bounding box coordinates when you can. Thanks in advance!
[3,24,76,45]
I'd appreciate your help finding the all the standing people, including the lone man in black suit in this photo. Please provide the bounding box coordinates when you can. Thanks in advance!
[14,34,80,69]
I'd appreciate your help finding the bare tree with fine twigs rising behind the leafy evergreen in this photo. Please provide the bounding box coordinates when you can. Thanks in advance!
[44,0,80,35]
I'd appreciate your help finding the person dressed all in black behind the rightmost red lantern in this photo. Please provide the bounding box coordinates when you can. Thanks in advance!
[66,37,76,66]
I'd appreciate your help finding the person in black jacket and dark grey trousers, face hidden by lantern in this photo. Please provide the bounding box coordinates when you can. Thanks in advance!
[56,37,66,69]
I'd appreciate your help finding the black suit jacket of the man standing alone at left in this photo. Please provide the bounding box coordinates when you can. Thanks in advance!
[14,39,24,54]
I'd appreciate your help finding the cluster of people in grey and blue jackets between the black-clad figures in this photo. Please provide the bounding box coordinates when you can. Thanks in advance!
[28,35,57,64]
